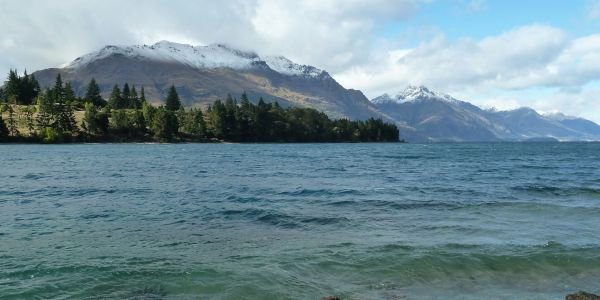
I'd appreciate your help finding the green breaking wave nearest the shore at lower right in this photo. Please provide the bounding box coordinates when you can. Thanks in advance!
[359,241,600,281]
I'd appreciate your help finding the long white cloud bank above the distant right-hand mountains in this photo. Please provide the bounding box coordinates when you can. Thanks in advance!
[337,25,600,96]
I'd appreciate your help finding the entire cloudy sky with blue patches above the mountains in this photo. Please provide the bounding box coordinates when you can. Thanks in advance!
[0,0,600,123]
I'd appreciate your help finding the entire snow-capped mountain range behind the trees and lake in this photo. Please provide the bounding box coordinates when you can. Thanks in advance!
[34,41,600,142]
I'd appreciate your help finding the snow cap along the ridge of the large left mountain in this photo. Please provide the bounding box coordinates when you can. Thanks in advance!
[63,41,323,77]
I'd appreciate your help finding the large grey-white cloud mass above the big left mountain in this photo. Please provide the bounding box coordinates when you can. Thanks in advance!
[0,0,419,72]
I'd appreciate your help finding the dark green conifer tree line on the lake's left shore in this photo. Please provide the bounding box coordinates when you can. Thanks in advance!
[0,70,399,143]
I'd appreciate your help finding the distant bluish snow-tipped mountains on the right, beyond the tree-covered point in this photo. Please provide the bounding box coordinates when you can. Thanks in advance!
[372,86,600,142]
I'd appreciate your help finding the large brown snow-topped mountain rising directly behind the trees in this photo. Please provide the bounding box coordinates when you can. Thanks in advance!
[34,42,390,121]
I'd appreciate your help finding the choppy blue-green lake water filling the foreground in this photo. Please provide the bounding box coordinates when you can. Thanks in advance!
[0,144,600,299]
